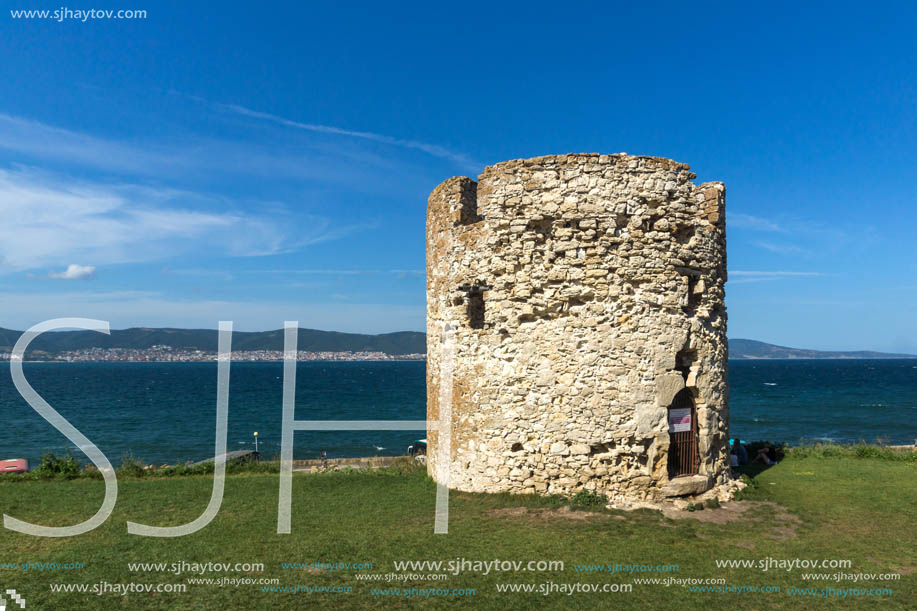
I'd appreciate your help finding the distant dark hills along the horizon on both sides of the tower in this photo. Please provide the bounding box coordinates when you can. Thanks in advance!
[0,328,917,359]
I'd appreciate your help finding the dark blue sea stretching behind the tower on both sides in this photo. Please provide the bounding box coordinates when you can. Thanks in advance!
[0,360,917,464]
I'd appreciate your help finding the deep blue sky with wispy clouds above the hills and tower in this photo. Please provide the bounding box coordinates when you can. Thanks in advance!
[0,0,917,352]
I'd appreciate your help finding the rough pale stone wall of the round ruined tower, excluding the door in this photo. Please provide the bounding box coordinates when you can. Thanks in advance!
[427,153,729,501]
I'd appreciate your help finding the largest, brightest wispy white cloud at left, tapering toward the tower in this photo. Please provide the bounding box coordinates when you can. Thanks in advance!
[0,169,360,271]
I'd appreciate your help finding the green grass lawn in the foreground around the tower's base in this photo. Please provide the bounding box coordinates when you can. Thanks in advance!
[0,456,917,610]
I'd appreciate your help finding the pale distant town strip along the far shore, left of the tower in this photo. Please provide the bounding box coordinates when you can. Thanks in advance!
[0,346,426,363]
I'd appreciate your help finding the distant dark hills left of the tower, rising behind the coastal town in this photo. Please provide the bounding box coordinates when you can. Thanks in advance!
[0,328,427,355]
